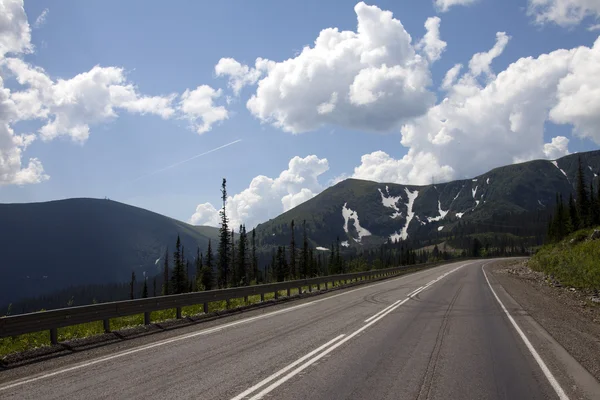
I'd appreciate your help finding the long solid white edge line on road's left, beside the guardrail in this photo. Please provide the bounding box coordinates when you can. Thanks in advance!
[0,264,464,391]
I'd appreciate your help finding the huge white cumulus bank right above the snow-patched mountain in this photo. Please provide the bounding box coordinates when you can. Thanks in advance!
[353,34,600,184]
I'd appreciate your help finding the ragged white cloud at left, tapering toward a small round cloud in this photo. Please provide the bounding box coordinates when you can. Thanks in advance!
[3,58,174,142]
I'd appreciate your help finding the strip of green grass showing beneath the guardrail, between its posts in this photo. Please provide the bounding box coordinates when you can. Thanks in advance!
[0,268,404,357]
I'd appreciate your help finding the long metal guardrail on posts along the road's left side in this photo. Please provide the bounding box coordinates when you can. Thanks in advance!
[0,262,450,344]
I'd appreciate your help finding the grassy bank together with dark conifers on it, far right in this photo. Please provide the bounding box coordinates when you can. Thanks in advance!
[529,160,600,296]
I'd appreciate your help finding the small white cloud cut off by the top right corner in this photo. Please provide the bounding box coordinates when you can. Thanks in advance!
[527,0,600,27]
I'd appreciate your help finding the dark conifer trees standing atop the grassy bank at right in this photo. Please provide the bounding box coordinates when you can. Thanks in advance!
[548,158,600,243]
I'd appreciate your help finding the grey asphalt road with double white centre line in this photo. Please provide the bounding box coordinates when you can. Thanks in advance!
[0,261,566,400]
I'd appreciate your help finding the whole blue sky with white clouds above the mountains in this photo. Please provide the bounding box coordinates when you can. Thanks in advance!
[0,0,600,225]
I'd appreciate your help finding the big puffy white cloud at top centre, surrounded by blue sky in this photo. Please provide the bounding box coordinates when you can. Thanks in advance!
[238,2,445,133]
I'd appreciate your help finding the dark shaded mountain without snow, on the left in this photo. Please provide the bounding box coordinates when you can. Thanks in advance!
[0,199,218,305]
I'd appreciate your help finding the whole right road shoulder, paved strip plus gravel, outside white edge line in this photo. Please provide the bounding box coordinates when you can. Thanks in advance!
[485,261,600,399]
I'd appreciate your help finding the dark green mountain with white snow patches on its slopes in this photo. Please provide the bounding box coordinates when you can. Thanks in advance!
[256,151,600,248]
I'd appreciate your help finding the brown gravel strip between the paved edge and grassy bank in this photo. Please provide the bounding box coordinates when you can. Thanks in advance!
[489,261,600,381]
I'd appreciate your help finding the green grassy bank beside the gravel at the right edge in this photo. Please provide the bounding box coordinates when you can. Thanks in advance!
[529,229,600,290]
